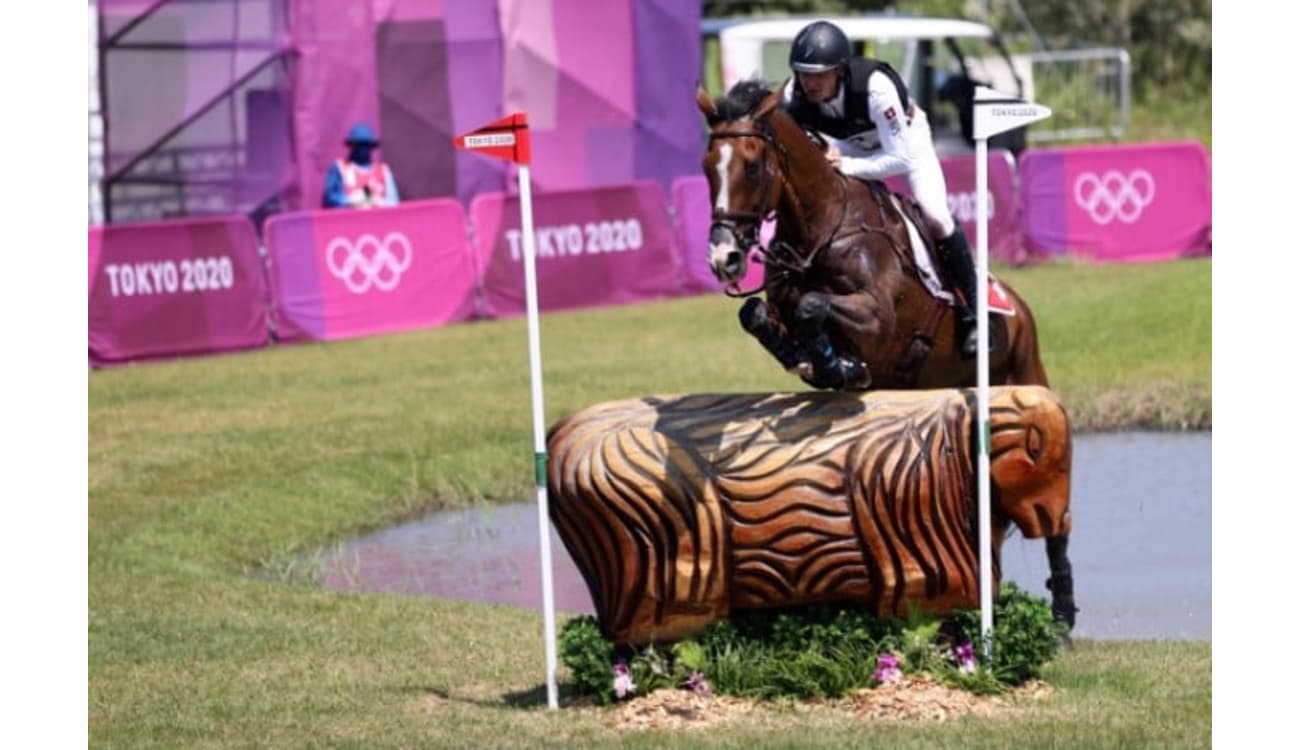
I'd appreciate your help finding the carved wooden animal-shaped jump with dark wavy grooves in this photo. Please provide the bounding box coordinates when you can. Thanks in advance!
[547,386,1071,645]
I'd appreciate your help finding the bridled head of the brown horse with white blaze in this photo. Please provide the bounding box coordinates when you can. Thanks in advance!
[696,81,783,283]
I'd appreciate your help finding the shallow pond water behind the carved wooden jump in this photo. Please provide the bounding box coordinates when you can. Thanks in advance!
[301,433,1212,640]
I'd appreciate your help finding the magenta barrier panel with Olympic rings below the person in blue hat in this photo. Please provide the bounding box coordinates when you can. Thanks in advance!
[265,198,475,341]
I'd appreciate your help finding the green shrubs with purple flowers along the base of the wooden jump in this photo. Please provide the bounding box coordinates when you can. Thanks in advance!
[560,582,1063,703]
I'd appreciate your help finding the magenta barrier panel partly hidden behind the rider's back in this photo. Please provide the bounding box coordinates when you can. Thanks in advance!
[885,148,1028,265]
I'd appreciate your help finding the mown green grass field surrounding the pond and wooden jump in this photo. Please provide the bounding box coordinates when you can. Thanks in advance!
[87,260,1212,747]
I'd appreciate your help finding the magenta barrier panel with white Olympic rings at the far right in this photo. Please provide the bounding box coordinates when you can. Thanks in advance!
[1021,142,1212,263]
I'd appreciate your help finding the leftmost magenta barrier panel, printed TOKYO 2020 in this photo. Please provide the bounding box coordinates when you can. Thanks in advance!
[88,216,269,367]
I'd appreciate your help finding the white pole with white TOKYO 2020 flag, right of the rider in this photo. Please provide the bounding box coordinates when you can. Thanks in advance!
[967,86,1052,664]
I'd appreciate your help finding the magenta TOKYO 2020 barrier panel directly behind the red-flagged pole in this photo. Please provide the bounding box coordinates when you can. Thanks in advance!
[469,182,684,317]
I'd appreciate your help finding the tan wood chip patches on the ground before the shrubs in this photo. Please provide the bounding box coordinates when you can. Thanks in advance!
[595,676,1052,732]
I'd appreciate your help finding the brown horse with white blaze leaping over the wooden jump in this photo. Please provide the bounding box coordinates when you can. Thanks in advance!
[697,81,1075,627]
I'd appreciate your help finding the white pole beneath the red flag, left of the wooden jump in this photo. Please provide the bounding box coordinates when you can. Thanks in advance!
[519,164,559,708]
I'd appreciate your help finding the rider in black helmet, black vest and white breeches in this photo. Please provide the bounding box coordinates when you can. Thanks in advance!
[784,21,978,359]
